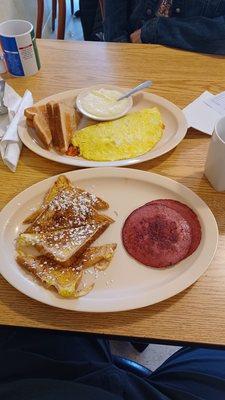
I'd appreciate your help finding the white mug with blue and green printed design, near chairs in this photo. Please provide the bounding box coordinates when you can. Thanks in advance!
[0,19,41,76]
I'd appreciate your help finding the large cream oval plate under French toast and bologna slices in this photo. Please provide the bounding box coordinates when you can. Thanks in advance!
[0,168,218,312]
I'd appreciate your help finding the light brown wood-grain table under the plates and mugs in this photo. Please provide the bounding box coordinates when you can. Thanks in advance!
[0,40,225,345]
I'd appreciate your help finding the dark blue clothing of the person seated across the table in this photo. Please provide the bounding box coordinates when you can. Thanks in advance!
[104,0,225,54]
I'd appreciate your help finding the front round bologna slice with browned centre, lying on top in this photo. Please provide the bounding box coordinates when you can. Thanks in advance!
[122,204,192,268]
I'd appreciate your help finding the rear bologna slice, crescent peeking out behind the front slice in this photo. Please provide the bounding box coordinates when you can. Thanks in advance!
[148,199,202,257]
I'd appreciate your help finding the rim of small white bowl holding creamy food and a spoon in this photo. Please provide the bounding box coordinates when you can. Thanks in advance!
[76,84,133,121]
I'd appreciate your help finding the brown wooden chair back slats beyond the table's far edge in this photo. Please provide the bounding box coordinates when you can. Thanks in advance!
[36,0,74,39]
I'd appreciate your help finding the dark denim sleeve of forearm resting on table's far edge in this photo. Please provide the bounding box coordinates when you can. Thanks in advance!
[140,16,225,54]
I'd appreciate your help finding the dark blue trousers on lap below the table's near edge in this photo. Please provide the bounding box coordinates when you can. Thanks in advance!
[0,328,225,400]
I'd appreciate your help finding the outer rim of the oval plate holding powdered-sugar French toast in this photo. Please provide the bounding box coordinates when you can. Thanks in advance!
[0,167,219,313]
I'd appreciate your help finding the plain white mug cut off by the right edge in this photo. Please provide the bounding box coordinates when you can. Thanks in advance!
[205,117,225,192]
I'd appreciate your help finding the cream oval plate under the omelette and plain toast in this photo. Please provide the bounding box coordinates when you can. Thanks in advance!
[18,85,187,167]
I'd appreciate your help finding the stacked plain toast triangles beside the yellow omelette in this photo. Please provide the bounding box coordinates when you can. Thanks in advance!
[24,98,81,154]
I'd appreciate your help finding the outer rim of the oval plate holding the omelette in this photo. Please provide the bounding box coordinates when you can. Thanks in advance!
[18,85,188,168]
